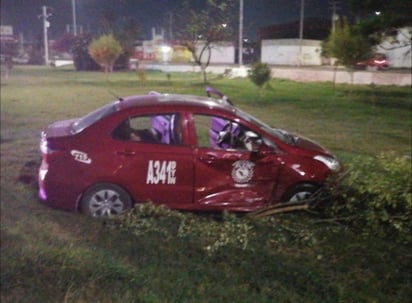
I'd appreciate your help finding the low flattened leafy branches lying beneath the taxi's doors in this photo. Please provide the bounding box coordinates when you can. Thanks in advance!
[113,203,253,254]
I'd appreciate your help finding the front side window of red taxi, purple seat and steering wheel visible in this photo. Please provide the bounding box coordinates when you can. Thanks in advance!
[193,114,262,151]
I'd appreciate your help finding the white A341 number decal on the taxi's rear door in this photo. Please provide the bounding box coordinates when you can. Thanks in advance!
[146,160,177,184]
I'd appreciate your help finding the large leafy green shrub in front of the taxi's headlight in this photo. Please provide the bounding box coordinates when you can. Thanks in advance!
[333,153,412,243]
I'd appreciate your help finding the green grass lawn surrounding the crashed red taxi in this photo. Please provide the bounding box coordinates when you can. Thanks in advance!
[0,66,412,303]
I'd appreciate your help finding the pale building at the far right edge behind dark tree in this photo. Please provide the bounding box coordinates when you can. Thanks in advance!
[376,27,412,68]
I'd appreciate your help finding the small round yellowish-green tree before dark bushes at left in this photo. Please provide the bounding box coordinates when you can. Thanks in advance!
[88,34,122,73]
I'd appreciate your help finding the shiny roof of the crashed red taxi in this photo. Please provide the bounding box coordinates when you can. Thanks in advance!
[116,93,234,111]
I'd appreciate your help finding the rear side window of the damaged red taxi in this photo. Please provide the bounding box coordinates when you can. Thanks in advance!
[112,114,182,145]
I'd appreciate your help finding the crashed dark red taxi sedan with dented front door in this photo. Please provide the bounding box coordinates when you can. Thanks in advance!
[38,88,340,216]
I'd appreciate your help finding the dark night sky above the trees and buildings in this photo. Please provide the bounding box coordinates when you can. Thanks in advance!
[0,0,345,40]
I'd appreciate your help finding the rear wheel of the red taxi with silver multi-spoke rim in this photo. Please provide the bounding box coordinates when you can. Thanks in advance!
[80,183,132,217]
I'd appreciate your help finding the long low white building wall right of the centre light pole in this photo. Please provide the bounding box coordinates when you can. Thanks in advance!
[261,39,322,66]
